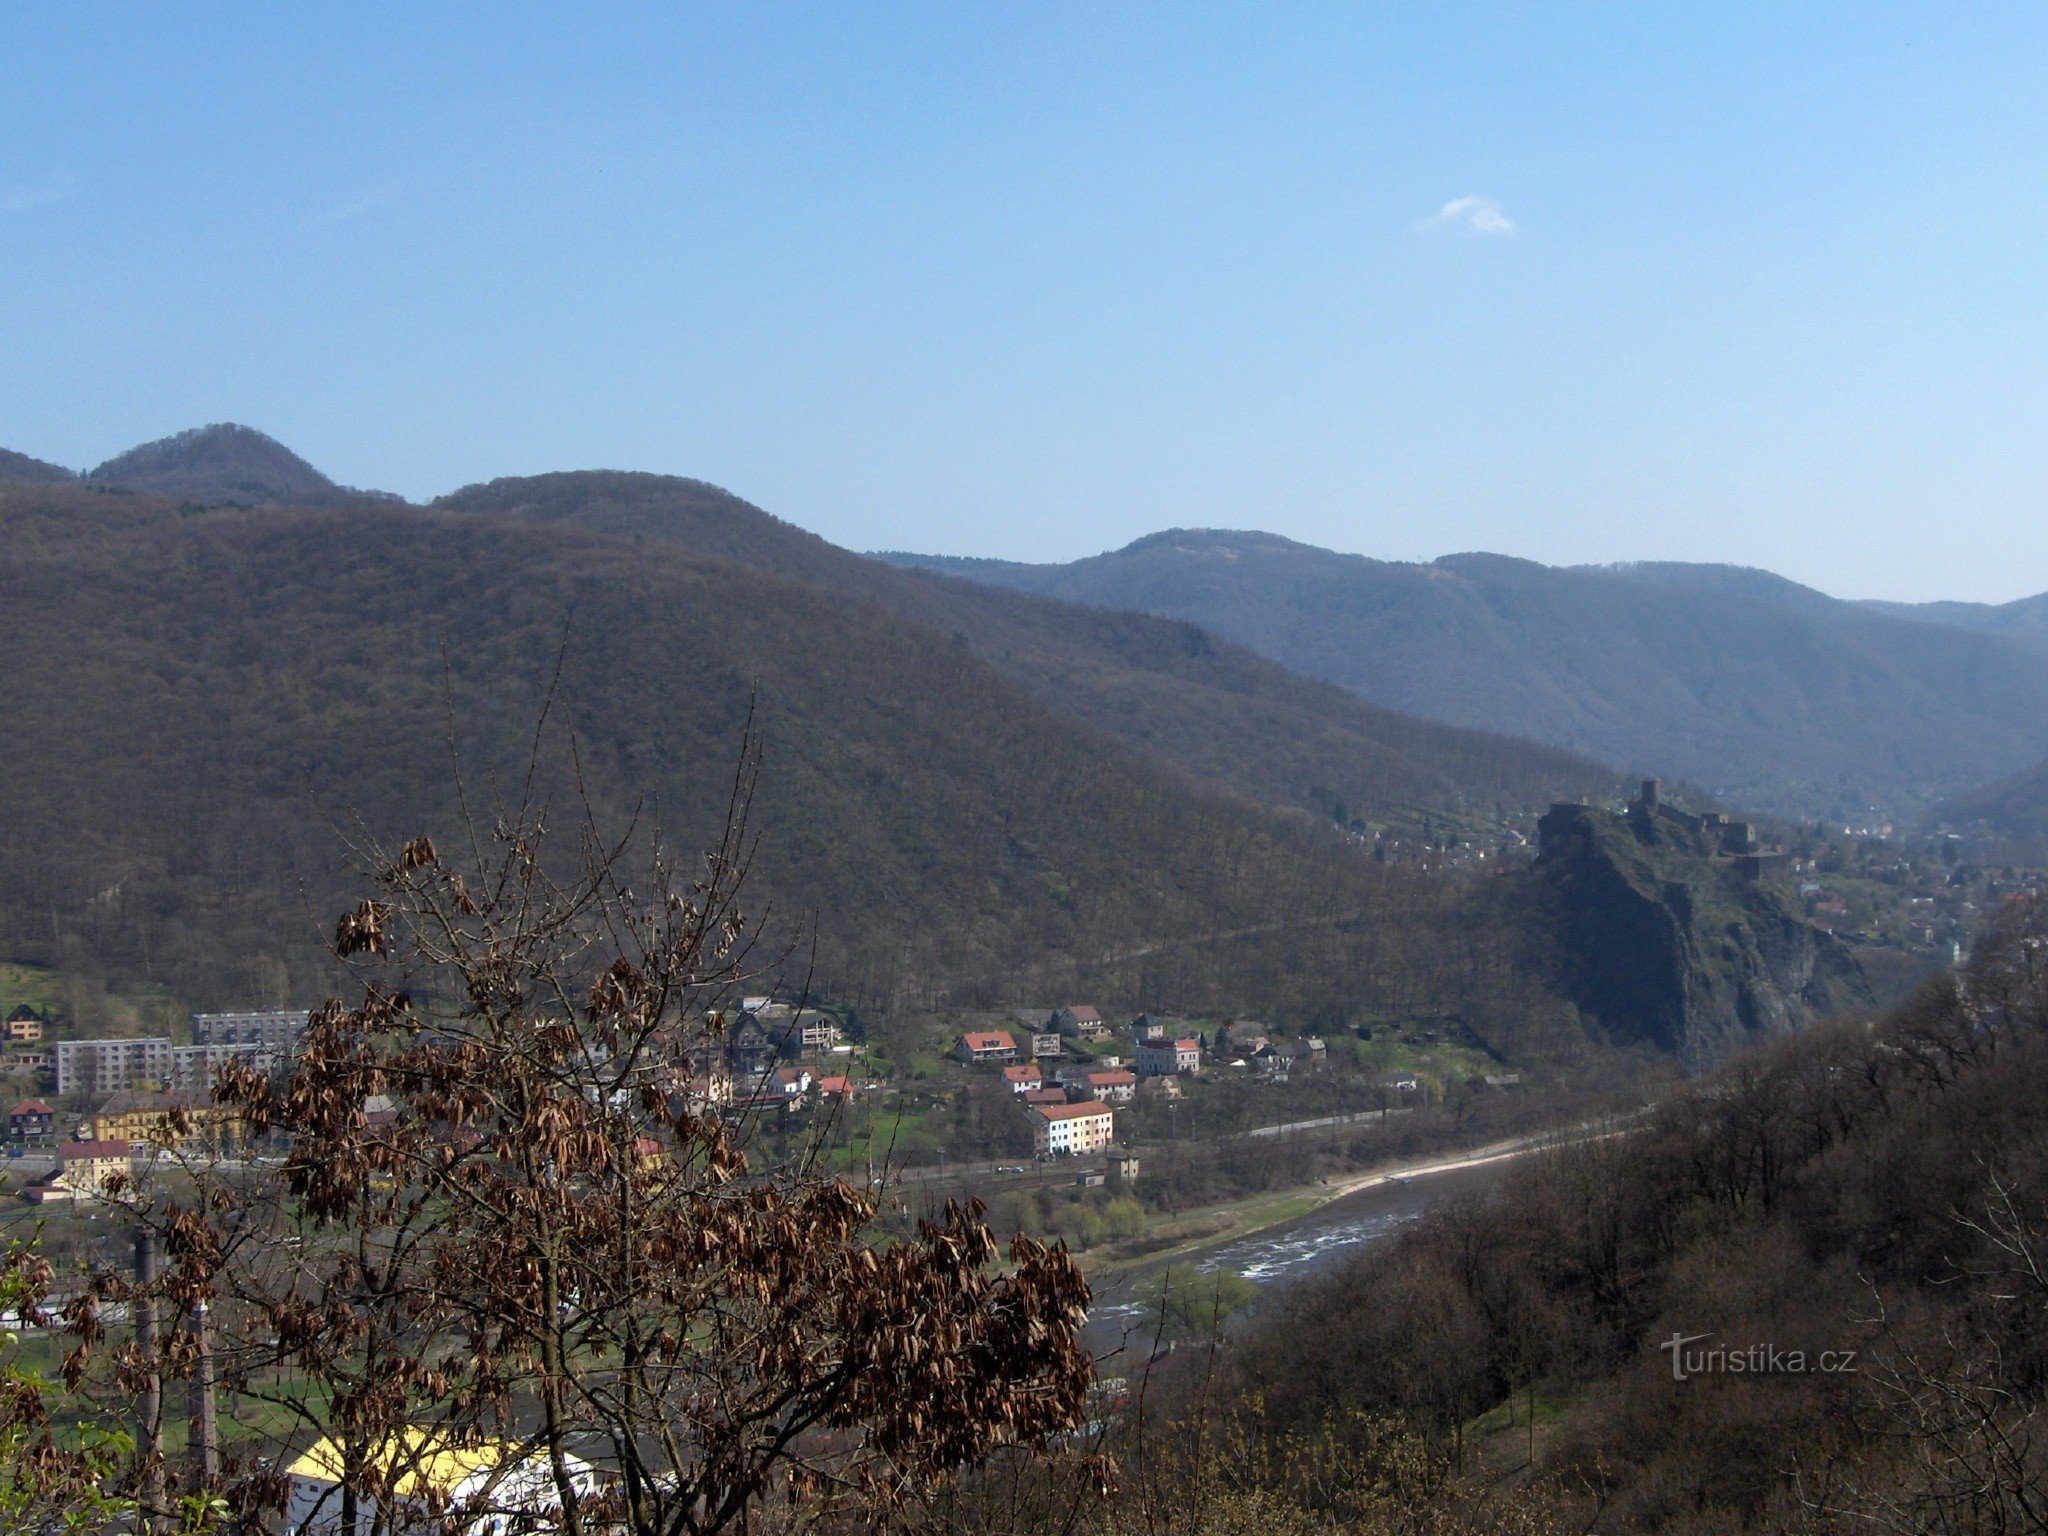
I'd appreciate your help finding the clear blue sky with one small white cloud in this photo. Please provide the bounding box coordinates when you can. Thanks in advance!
[0,4,2048,600]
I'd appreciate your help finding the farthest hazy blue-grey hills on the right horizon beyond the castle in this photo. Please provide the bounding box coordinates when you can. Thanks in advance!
[887,530,2048,815]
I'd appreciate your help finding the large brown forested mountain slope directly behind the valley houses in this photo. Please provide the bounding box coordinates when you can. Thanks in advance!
[0,483,1583,1055]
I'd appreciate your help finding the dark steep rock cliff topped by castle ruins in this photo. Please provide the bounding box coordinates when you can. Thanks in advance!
[1536,803,1870,1069]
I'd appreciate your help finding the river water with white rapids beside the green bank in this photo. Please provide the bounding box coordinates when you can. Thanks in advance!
[1087,1161,1511,1372]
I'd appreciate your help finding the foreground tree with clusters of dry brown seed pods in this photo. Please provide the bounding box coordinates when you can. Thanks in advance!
[72,724,1092,1536]
